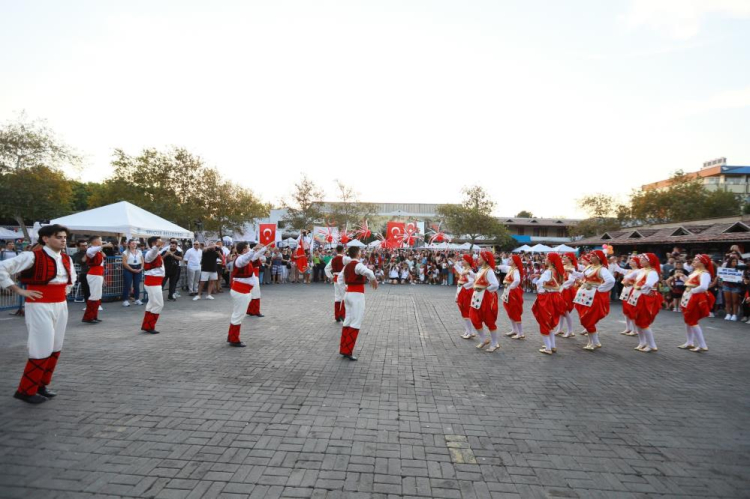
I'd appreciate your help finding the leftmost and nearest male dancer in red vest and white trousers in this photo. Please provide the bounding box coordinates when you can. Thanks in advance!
[0,224,76,404]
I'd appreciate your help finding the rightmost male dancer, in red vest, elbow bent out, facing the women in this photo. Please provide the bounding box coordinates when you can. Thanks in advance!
[339,246,378,360]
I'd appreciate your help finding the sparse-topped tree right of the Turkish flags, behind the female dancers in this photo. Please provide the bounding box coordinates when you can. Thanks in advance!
[437,185,511,250]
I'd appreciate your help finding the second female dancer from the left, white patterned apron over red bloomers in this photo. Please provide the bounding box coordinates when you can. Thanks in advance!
[469,251,500,352]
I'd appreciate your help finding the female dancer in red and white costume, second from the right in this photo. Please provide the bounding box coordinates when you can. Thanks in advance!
[633,253,664,352]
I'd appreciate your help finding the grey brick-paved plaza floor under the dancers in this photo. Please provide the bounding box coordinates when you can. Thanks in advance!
[0,285,750,499]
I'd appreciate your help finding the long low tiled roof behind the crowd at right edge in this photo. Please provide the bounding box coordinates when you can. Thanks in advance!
[570,221,750,246]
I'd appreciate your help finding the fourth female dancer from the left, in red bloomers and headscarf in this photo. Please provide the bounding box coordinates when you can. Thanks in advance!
[531,253,565,353]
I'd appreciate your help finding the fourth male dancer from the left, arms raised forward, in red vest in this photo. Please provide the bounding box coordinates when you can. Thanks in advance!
[232,242,266,347]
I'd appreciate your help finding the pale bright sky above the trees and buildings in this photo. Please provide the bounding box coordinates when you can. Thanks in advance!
[0,0,750,217]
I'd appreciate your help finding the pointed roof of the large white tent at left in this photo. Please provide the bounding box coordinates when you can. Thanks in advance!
[50,201,193,239]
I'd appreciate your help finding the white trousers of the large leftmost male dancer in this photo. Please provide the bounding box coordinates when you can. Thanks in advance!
[26,301,68,359]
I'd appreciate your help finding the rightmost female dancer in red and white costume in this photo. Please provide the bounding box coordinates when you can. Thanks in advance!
[680,255,716,352]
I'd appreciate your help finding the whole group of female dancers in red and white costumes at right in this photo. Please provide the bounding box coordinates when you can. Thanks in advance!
[455,250,715,355]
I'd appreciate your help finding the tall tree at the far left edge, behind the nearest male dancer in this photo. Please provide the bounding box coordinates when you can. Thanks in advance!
[0,114,80,240]
